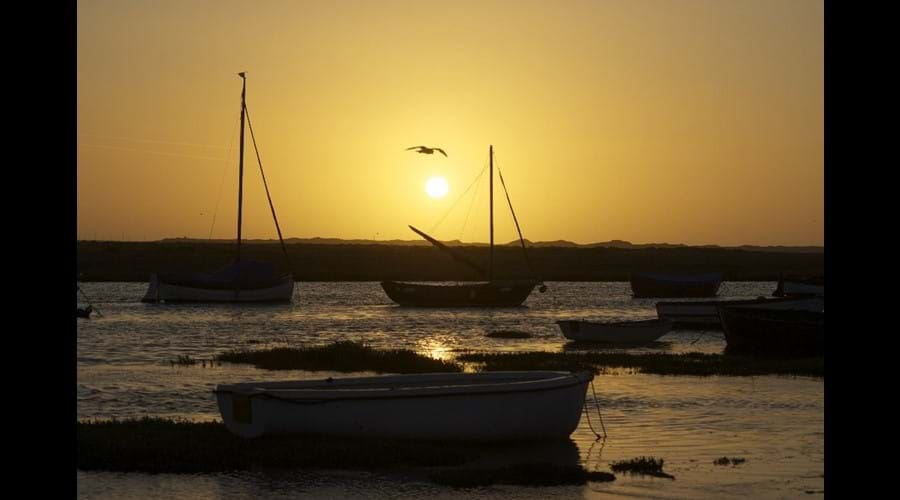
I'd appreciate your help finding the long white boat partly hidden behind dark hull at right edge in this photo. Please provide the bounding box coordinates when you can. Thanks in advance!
[656,297,820,328]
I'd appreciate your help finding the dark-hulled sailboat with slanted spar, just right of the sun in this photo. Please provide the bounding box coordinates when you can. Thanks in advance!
[381,146,547,307]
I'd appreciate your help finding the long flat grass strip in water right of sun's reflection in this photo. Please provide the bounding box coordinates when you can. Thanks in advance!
[456,352,825,377]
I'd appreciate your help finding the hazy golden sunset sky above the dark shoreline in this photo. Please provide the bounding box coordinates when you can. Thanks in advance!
[77,0,824,245]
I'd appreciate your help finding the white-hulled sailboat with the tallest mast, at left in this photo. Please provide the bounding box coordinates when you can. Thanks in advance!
[142,72,294,302]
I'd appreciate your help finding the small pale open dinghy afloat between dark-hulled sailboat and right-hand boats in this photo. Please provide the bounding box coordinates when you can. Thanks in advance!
[556,319,672,344]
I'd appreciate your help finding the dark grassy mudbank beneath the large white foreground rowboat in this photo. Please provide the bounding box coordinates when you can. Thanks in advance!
[76,418,615,487]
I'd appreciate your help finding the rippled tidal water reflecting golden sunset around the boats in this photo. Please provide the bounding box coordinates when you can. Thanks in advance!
[77,282,825,499]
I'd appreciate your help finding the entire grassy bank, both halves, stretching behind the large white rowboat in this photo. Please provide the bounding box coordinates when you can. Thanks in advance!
[216,342,825,377]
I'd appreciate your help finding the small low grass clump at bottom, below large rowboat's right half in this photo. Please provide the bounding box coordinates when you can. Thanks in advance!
[431,464,616,488]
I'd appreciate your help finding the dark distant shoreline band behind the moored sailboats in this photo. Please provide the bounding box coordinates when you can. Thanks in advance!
[77,239,825,282]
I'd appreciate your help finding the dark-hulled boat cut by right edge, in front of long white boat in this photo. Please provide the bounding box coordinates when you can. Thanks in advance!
[717,299,825,357]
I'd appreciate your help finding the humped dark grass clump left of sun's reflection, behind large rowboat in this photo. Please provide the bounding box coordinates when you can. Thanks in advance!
[216,341,462,373]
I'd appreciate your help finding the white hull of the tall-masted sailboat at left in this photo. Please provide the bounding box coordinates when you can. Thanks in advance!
[141,274,294,302]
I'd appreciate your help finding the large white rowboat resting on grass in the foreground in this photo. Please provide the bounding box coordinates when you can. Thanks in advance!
[215,371,594,441]
